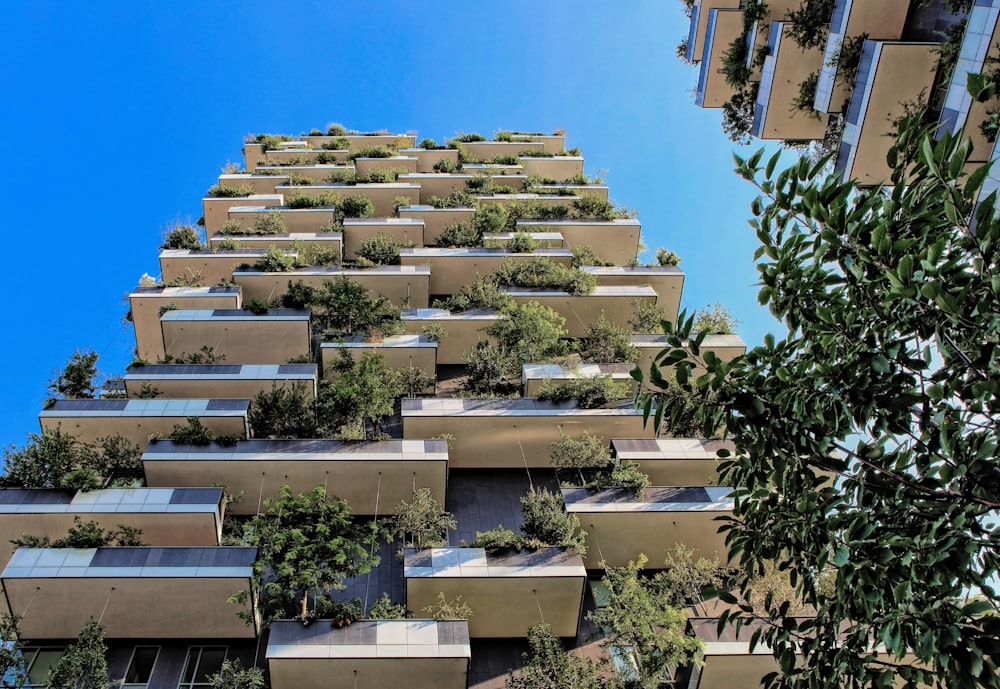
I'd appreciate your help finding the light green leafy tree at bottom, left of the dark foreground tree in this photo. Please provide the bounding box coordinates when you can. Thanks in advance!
[587,555,704,689]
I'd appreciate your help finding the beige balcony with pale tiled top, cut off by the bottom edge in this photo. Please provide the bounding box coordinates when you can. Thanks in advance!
[267,620,472,689]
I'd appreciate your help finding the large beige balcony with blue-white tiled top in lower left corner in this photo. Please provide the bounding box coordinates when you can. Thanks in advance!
[0,547,257,641]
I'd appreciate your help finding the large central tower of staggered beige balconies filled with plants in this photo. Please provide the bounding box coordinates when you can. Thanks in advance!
[0,125,756,689]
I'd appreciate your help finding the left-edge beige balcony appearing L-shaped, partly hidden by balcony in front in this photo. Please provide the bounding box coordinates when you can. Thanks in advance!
[128,287,243,361]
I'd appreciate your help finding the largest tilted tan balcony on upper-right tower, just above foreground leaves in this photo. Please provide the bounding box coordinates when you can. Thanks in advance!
[836,40,938,185]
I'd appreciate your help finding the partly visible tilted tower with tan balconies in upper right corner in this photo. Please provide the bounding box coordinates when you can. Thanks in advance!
[678,0,1000,184]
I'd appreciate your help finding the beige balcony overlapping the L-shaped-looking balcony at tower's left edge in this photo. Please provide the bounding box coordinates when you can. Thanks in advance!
[160,309,311,364]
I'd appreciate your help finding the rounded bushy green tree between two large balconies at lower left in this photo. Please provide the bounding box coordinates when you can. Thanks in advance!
[233,486,378,622]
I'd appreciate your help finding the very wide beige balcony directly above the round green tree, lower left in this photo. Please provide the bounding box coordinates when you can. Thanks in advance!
[142,439,448,515]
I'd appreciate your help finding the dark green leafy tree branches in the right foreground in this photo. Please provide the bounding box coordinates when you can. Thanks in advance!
[637,123,1000,689]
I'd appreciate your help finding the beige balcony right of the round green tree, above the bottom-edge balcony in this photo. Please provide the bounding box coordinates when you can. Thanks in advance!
[403,548,587,639]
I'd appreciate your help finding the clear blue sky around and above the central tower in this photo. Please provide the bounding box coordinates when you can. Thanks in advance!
[0,0,791,445]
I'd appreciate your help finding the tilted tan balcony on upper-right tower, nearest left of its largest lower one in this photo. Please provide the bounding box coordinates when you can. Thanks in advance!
[750,21,826,141]
